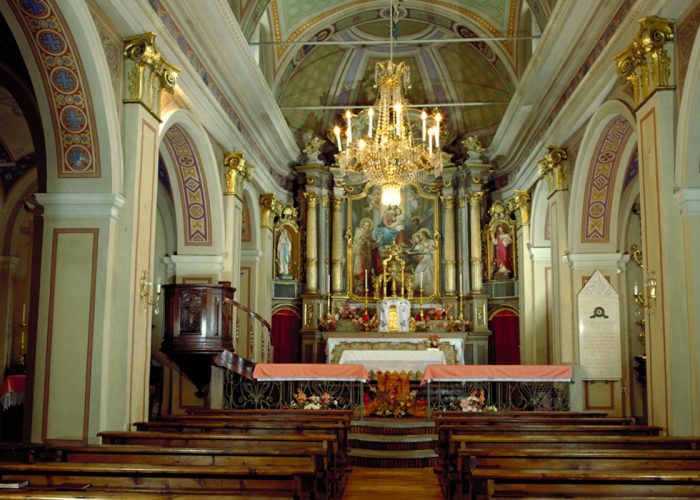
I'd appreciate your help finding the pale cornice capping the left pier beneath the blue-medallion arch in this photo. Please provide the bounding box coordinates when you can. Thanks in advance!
[35,193,124,219]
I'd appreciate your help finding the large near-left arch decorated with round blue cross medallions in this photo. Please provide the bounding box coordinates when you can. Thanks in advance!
[6,0,123,192]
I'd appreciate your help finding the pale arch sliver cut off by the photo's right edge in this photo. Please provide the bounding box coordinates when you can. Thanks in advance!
[676,31,700,188]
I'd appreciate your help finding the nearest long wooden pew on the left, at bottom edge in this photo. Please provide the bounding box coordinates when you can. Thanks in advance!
[0,462,315,498]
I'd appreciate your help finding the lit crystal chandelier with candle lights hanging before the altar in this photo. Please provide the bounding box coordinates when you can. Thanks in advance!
[333,60,442,205]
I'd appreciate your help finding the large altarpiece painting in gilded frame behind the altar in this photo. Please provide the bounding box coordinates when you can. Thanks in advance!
[345,183,441,301]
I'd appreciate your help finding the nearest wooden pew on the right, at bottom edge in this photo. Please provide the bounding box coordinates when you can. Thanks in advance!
[472,468,700,499]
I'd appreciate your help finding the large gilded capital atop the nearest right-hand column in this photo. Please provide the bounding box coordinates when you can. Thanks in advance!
[615,16,675,107]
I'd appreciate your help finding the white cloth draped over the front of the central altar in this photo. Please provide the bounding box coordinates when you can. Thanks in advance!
[339,349,445,373]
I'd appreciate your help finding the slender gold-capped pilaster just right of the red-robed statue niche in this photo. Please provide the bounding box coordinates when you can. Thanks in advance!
[508,190,537,364]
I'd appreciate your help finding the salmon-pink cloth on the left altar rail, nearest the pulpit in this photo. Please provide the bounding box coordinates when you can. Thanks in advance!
[253,363,369,382]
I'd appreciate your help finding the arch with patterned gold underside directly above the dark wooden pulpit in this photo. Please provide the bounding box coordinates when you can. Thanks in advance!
[160,109,224,255]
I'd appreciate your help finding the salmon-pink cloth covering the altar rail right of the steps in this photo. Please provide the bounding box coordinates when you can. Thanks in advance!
[421,365,573,385]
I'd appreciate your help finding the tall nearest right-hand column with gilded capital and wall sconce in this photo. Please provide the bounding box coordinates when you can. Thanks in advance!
[616,17,700,435]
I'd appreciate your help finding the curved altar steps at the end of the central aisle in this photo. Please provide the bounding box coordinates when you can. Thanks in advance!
[349,418,437,468]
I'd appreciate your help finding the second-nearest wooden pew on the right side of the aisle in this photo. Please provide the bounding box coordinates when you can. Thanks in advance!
[456,448,700,498]
